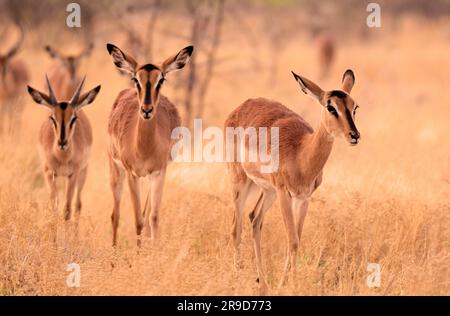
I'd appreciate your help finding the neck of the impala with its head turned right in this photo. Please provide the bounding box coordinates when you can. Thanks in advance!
[298,118,334,181]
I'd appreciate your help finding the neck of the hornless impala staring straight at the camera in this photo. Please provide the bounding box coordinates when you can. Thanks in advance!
[135,109,157,158]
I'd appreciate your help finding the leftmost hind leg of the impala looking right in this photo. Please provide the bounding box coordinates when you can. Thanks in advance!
[231,177,252,270]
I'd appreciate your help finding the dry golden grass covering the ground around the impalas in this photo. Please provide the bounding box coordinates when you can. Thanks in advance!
[0,1,450,295]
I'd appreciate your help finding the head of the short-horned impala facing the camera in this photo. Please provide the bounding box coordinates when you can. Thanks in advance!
[28,76,100,151]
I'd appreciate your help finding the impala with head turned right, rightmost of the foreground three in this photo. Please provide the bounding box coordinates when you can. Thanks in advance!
[225,70,360,294]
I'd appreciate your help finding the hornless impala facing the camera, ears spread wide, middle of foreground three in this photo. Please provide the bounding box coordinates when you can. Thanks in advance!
[107,44,194,246]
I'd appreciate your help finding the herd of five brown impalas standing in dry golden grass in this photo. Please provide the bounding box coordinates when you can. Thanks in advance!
[0,22,360,294]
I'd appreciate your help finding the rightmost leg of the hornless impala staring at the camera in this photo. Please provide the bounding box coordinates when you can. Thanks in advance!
[145,169,166,241]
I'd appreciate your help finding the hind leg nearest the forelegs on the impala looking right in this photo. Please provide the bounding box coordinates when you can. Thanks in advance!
[250,190,276,295]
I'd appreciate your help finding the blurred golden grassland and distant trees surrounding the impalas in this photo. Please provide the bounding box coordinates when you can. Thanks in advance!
[0,0,450,295]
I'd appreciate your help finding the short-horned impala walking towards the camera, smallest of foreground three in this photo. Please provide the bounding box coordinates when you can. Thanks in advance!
[28,77,100,230]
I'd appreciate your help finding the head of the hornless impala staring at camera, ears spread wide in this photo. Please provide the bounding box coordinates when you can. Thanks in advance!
[106,44,194,120]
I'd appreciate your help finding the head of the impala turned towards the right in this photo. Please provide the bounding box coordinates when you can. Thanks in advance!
[292,69,360,145]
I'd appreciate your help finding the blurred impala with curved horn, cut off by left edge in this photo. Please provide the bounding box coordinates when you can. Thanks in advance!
[0,26,29,134]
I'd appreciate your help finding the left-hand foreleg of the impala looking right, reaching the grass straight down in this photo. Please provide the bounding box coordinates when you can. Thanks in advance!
[278,190,299,287]
